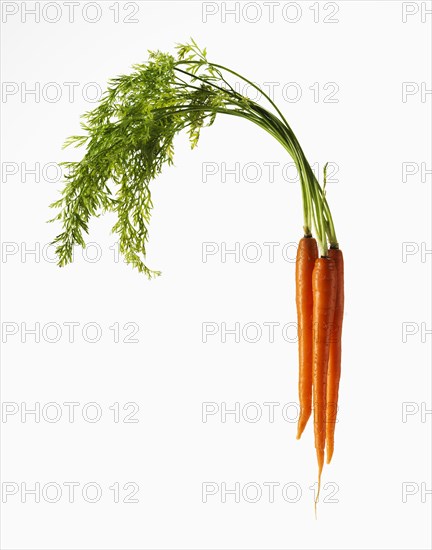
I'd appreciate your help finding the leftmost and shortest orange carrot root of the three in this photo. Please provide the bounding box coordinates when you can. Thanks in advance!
[296,236,318,439]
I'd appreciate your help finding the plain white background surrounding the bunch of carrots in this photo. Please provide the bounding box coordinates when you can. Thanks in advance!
[1,1,431,550]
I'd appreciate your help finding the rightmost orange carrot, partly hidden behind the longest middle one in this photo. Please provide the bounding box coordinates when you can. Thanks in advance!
[326,248,344,464]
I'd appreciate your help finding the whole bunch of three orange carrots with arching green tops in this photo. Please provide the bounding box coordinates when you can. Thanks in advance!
[51,39,344,512]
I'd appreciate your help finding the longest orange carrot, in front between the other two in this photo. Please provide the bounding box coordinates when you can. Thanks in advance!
[312,257,337,504]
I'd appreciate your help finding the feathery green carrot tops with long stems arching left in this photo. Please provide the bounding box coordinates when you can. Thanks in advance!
[50,40,333,278]
